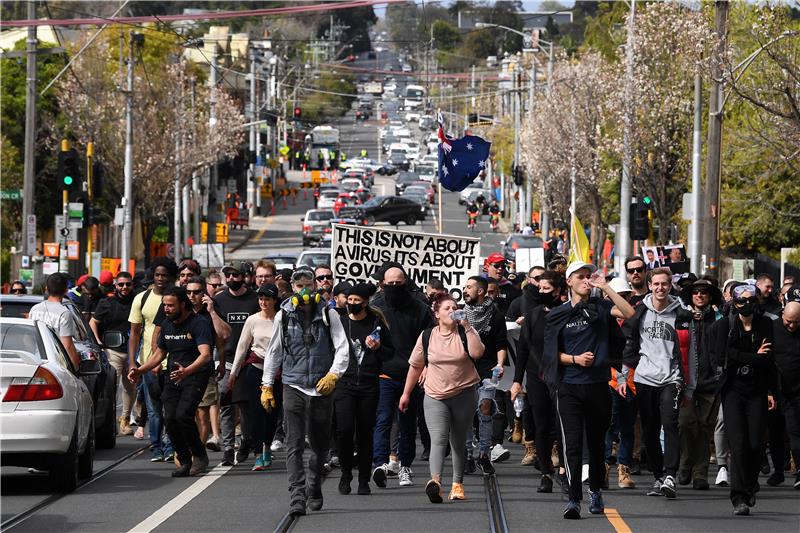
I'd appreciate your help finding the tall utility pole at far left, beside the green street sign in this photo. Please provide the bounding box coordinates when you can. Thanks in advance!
[21,1,38,256]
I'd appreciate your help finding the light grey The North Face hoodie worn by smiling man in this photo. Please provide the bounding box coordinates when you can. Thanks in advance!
[633,294,681,387]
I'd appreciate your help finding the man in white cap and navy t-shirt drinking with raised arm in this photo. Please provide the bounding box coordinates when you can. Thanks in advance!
[542,261,634,520]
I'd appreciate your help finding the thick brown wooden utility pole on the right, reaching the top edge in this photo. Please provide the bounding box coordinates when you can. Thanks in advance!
[703,0,729,274]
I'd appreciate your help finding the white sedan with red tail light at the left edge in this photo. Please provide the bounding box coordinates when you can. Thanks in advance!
[0,316,97,492]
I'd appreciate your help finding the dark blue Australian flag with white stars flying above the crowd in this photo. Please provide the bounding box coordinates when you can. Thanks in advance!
[439,118,492,192]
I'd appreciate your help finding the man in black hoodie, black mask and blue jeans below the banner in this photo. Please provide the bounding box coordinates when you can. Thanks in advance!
[372,266,434,488]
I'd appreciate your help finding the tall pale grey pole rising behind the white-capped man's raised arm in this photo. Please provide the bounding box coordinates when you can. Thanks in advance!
[614,0,636,272]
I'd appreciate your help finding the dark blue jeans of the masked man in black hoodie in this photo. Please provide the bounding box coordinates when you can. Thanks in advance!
[372,378,422,467]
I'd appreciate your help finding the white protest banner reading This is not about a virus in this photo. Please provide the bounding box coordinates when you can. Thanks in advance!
[331,224,481,301]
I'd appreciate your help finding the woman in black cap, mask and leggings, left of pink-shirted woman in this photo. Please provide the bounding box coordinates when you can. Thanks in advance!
[333,283,394,494]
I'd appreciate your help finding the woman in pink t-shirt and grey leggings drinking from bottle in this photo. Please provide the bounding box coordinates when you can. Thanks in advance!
[400,293,484,503]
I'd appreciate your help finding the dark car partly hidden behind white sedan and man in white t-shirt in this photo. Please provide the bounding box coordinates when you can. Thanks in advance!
[0,294,117,448]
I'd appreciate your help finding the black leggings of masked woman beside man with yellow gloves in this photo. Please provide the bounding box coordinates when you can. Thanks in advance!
[333,383,378,482]
